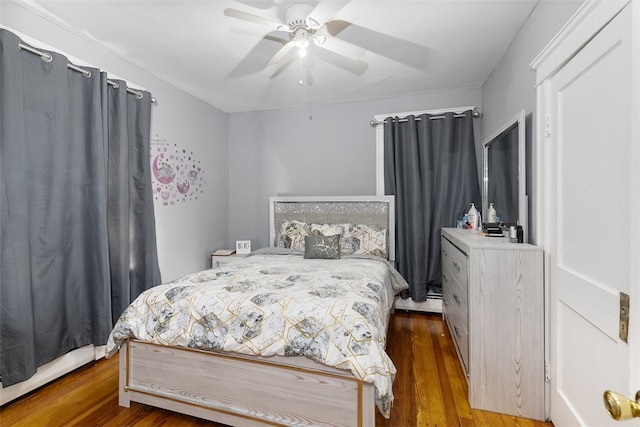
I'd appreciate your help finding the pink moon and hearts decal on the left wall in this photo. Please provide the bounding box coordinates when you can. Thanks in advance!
[151,135,206,206]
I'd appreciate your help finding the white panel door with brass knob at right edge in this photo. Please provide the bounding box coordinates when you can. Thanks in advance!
[545,6,640,427]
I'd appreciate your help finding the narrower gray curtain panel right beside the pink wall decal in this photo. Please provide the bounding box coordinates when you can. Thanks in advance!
[103,81,160,323]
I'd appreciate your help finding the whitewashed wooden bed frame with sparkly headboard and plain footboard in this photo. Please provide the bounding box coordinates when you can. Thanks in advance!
[119,196,395,427]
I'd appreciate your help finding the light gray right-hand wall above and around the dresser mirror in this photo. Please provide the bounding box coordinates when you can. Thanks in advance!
[476,0,582,243]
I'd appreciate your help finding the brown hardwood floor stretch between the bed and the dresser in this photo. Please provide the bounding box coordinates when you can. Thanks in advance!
[376,312,553,427]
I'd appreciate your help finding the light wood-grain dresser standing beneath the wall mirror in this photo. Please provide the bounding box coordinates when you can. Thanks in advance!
[441,228,545,420]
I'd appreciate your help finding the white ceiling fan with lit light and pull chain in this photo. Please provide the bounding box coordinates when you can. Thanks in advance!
[224,0,368,78]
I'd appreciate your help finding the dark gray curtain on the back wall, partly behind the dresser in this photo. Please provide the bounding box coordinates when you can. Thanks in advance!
[384,111,481,302]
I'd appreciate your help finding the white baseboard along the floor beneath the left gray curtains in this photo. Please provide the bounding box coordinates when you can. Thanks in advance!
[0,345,105,405]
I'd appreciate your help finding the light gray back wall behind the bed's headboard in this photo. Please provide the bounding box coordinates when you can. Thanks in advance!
[229,90,480,248]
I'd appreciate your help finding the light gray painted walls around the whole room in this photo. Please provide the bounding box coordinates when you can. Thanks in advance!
[0,0,580,280]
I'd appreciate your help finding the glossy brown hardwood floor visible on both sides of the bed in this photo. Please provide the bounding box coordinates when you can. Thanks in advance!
[0,312,553,427]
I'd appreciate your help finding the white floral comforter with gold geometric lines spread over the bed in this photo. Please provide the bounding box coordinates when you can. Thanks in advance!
[107,253,408,417]
